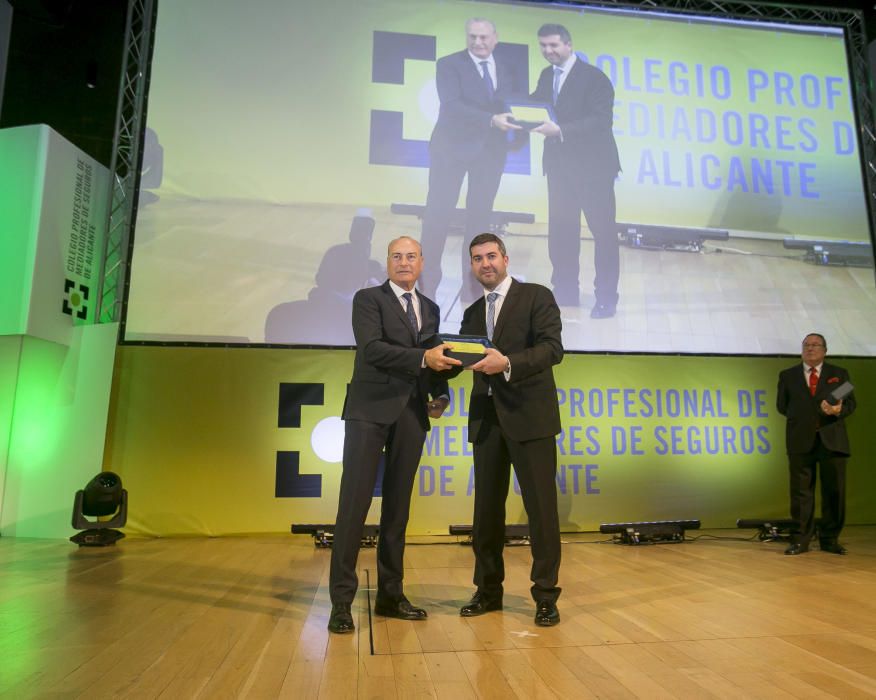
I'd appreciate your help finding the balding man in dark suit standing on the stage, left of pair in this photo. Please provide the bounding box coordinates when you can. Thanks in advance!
[328,236,459,633]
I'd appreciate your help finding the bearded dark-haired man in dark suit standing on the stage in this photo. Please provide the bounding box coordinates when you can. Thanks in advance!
[448,233,563,627]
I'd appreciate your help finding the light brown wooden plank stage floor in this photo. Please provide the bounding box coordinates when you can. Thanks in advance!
[0,526,876,700]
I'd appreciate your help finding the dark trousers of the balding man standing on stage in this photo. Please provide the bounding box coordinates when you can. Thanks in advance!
[329,391,426,603]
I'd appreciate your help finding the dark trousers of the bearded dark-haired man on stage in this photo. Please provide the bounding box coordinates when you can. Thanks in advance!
[472,400,561,601]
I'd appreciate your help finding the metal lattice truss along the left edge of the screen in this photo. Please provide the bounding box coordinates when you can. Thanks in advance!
[97,0,155,323]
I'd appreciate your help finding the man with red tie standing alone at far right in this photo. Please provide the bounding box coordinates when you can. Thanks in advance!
[776,333,855,555]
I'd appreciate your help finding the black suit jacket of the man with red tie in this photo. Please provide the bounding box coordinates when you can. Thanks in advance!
[776,362,855,455]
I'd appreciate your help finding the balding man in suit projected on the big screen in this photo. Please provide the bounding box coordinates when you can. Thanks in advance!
[421,18,520,299]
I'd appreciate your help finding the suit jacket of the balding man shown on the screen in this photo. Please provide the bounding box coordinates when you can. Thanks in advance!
[429,51,516,161]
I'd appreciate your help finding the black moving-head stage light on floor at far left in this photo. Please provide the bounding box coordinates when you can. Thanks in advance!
[70,472,128,547]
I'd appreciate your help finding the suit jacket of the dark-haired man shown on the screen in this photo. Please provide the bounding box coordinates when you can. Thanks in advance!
[532,57,621,179]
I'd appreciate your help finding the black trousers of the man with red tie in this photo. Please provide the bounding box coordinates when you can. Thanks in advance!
[788,437,847,544]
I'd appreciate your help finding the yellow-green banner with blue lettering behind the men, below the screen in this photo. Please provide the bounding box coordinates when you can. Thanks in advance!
[105,346,876,535]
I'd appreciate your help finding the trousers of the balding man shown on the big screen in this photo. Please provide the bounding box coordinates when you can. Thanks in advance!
[419,146,506,301]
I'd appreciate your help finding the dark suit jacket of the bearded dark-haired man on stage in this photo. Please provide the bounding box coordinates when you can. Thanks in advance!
[460,280,563,442]
